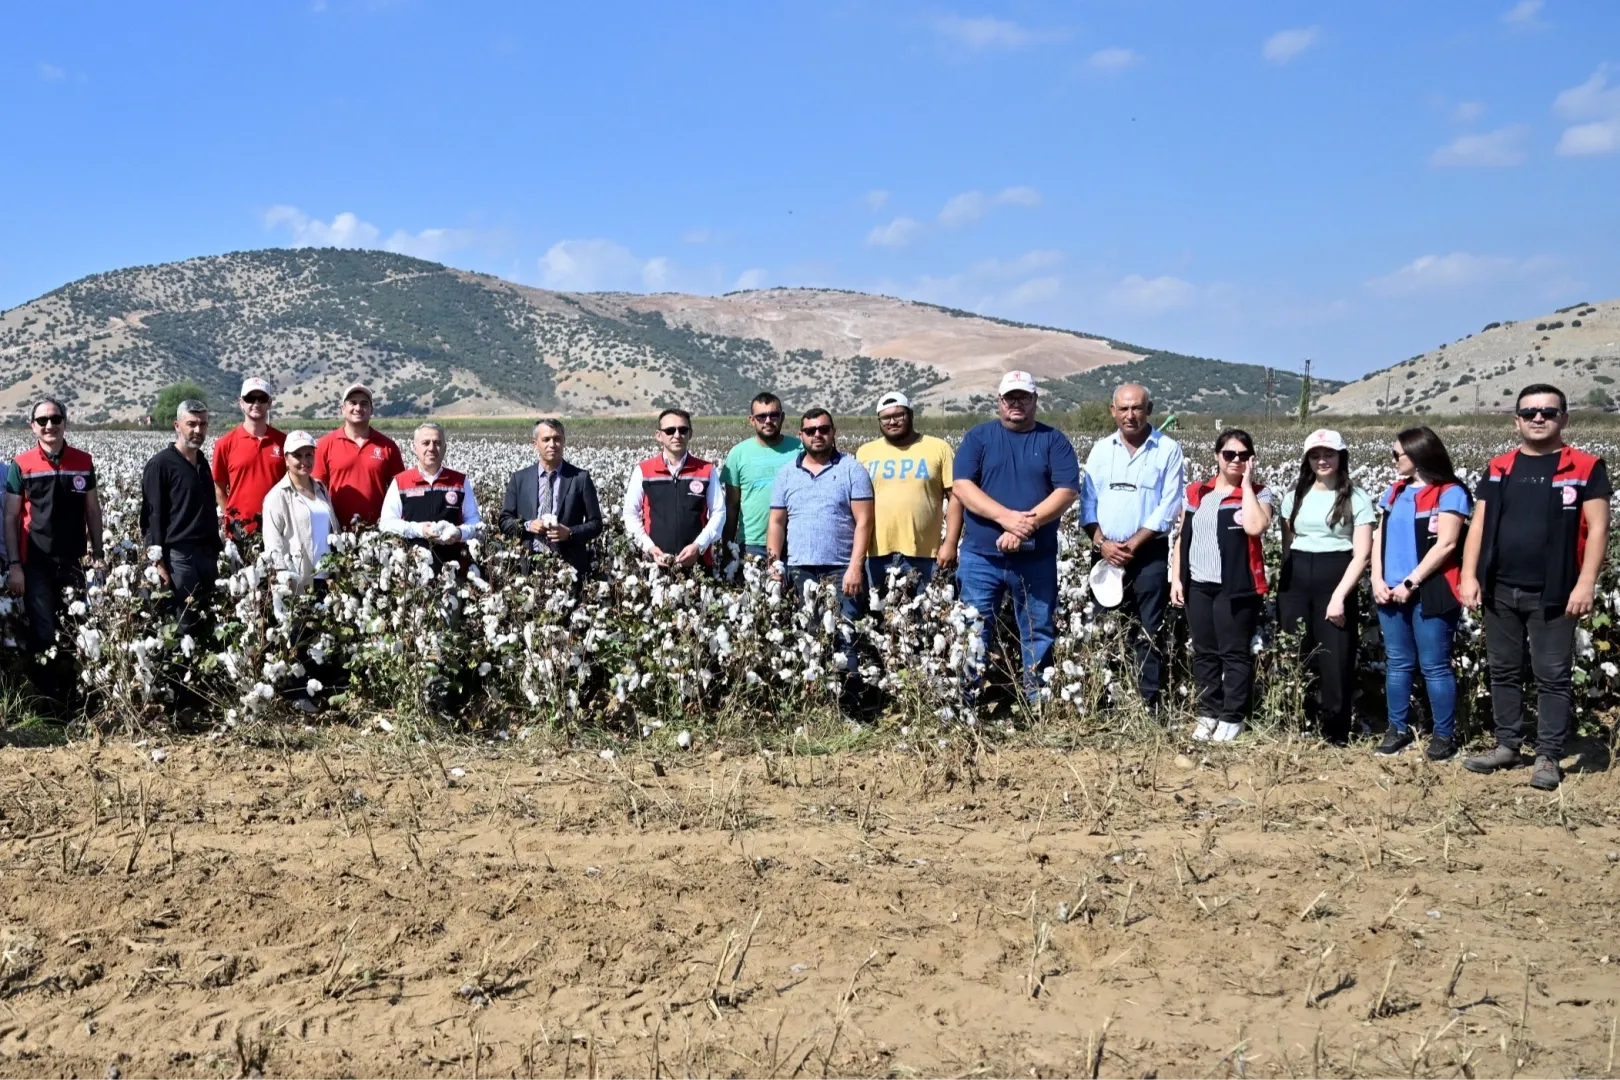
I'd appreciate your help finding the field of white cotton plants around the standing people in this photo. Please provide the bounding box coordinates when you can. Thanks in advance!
[0,421,1620,745]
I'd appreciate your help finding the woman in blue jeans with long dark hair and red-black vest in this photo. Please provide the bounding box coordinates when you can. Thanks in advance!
[1372,427,1469,761]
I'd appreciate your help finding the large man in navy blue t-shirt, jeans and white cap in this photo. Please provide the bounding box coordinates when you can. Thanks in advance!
[951,371,1081,699]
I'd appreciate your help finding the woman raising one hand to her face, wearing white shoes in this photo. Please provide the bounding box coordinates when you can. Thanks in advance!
[1170,427,1272,742]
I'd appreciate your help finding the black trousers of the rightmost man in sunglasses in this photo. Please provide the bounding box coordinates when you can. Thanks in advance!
[1486,585,1575,758]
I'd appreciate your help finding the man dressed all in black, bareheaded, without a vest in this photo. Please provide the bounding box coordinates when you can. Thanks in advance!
[141,400,224,640]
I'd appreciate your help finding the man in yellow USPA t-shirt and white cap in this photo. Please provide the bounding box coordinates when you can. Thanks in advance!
[855,390,962,589]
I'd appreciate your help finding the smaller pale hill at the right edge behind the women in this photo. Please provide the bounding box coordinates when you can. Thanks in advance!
[1320,300,1620,413]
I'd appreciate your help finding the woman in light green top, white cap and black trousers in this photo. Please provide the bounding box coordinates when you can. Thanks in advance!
[1277,429,1375,746]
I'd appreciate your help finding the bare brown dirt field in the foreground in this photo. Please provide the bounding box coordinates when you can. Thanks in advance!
[0,735,1620,1080]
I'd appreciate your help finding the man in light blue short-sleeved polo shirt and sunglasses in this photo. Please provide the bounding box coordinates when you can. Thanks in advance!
[765,408,872,704]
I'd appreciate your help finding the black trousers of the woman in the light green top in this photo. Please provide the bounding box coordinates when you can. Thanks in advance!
[1277,551,1361,742]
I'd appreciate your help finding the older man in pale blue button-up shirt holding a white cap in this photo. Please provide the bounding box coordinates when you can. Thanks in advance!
[1081,382,1186,709]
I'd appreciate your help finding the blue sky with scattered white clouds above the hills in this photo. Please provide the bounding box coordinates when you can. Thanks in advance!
[0,0,1620,377]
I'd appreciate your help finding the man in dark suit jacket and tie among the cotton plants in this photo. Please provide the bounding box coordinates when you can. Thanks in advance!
[501,419,603,581]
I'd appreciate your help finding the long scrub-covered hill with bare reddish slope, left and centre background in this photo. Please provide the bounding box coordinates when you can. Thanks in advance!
[0,248,1338,421]
